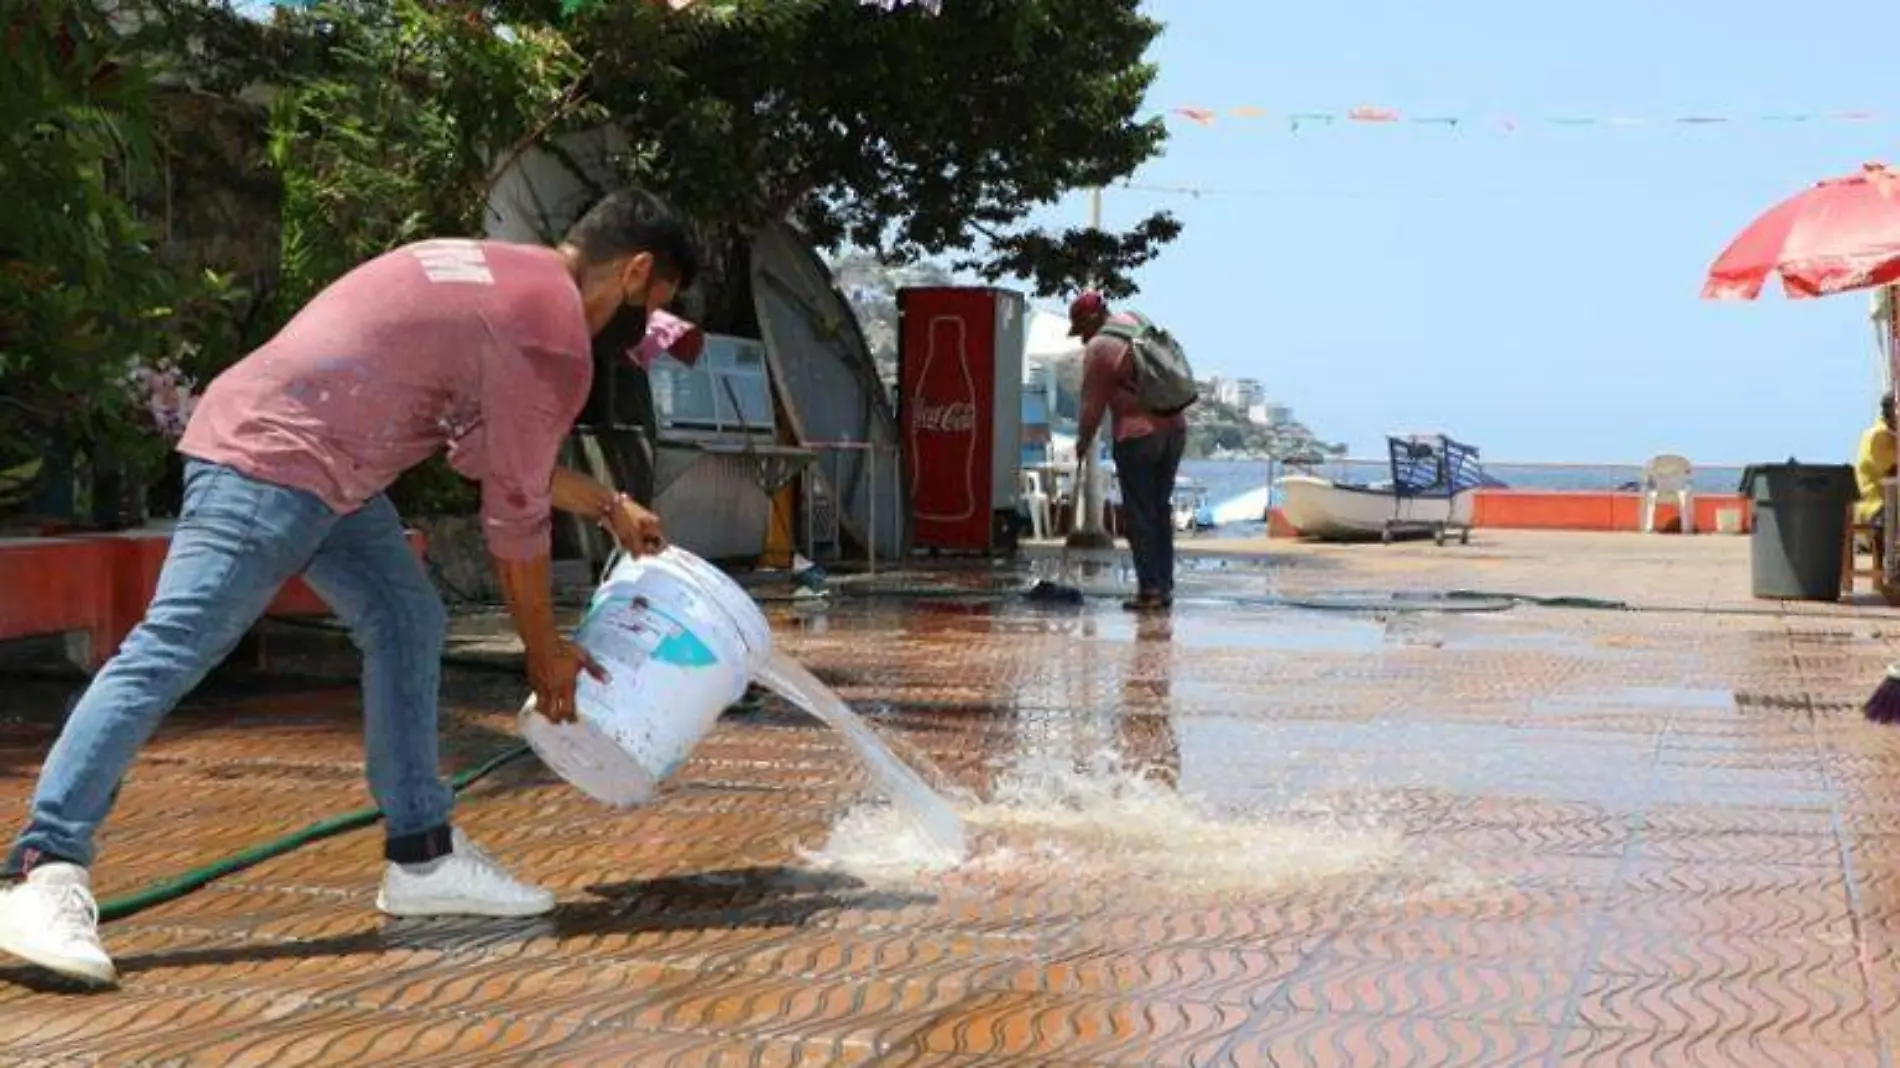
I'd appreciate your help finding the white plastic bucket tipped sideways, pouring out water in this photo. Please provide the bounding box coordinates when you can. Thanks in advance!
[521,549,771,808]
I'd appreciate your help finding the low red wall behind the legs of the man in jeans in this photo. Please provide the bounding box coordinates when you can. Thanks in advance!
[0,530,424,669]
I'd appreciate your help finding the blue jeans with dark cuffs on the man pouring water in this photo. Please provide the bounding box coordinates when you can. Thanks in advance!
[6,460,454,872]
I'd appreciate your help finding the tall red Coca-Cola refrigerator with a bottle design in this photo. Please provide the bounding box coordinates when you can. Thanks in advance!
[897,287,1024,553]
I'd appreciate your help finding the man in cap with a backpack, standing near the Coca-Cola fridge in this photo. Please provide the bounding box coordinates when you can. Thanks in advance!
[1070,291,1199,612]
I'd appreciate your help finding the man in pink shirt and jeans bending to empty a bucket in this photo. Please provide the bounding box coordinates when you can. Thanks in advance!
[0,192,697,982]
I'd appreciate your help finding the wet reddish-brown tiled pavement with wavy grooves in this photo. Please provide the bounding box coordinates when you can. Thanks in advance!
[11,534,1900,1068]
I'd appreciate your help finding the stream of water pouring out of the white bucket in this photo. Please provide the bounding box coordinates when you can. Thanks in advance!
[754,654,969,868]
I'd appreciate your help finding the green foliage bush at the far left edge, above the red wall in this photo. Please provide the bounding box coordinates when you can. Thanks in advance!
[0,0,239,502]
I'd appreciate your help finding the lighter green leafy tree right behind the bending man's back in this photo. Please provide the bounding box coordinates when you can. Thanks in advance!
[256,0,599,314]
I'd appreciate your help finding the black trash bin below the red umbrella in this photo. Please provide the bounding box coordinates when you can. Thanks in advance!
[1742,460,1858,601]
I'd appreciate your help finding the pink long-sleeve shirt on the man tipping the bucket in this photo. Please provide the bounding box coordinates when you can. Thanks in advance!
[179,239,593,561]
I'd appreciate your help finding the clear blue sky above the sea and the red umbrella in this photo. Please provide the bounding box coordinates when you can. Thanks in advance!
[995,0,1900,464]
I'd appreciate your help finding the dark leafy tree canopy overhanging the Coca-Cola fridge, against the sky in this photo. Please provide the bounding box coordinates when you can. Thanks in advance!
[516,0,1180,296]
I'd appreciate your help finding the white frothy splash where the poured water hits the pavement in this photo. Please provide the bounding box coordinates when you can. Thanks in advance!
[806,751,1402,899]
